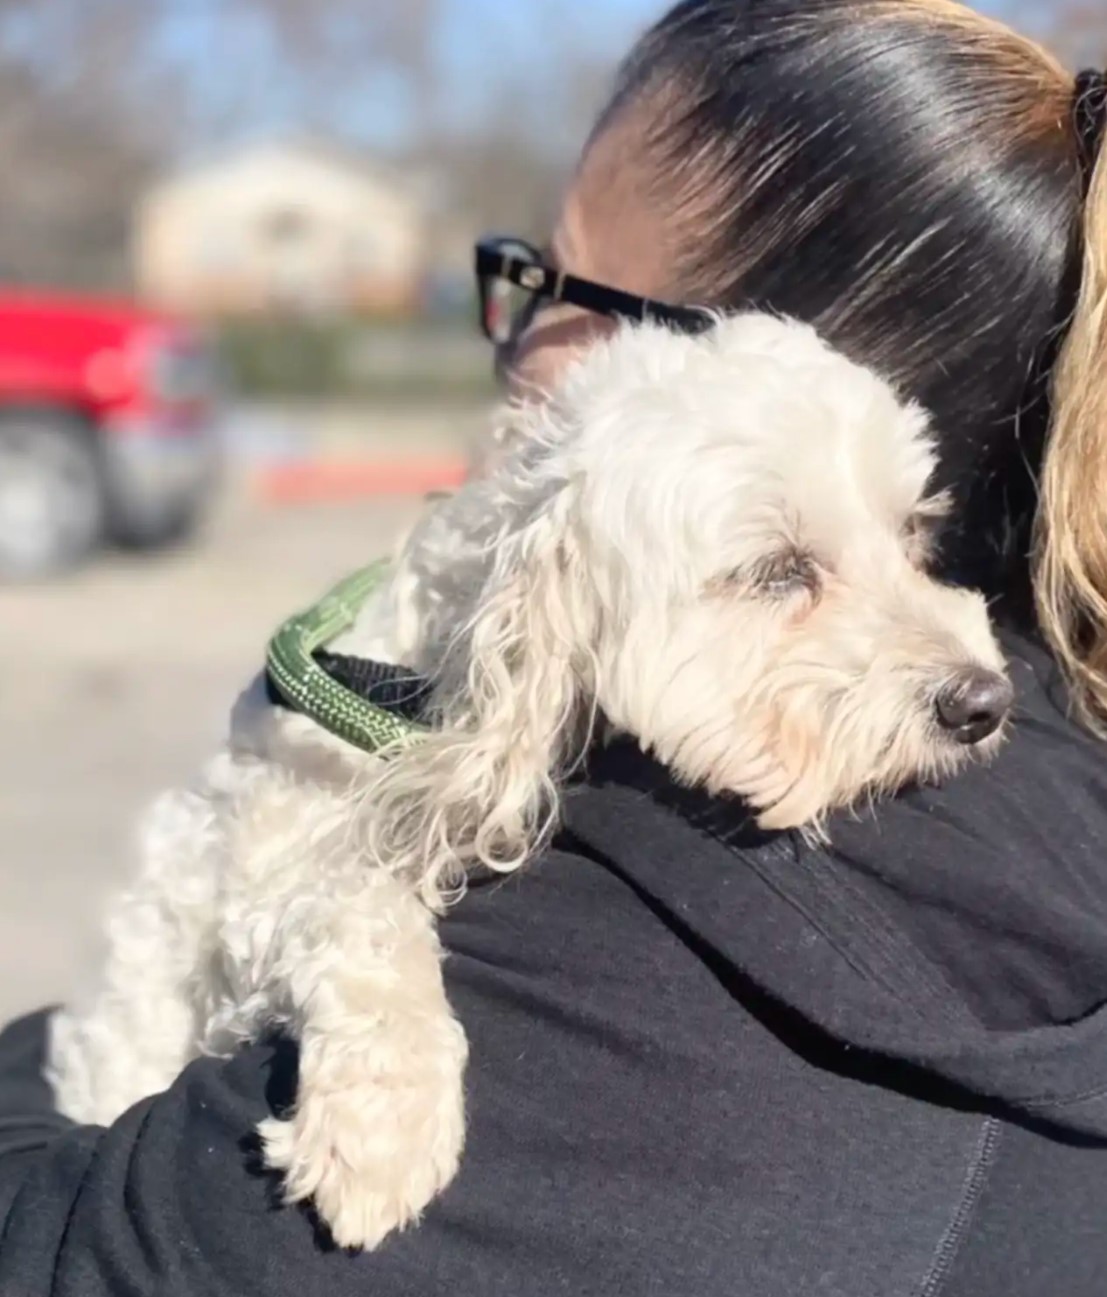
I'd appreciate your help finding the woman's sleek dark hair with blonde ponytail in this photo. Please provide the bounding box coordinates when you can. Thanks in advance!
[604,0,1107,719]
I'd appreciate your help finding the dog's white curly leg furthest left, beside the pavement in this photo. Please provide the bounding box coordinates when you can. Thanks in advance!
[47,755,240,1124]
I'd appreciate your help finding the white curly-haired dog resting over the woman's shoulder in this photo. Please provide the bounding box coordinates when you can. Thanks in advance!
[49,314,1011,1246]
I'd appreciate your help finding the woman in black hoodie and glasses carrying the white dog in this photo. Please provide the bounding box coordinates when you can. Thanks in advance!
[0,0,1107,1297]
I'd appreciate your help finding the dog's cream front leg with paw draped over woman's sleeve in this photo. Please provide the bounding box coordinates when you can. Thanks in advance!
[261,860,467,1248]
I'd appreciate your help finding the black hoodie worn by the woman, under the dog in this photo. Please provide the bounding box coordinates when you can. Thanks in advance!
[0,632,1107,1297]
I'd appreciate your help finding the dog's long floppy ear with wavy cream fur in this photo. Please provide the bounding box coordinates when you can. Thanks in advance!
[368,486,598,903]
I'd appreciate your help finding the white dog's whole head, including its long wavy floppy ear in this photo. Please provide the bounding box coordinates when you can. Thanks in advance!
[368,314,1011,887]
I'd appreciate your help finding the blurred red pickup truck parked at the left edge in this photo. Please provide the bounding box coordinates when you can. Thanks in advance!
[0,297,219,577]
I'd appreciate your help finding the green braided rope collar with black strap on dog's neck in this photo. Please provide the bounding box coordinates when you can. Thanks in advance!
[266,563,430,752]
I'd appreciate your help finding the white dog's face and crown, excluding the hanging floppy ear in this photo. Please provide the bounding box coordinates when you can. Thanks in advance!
[554,308,1011,827]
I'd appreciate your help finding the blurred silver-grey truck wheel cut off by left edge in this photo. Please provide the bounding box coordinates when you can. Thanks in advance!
[0,409,106,578]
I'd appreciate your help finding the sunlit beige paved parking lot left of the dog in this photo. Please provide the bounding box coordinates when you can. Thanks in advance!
[0,485,419,1021]
